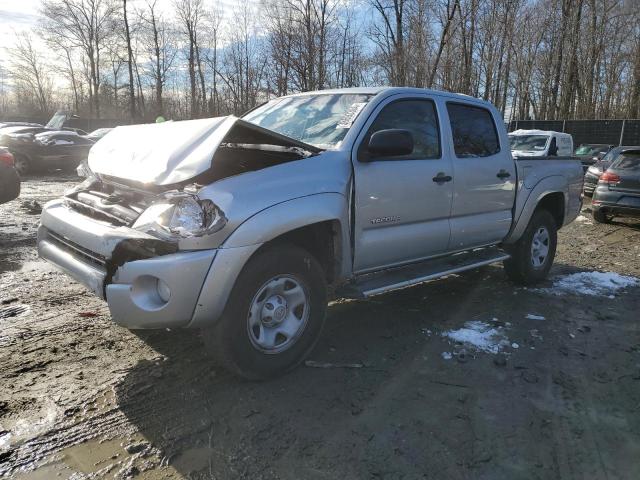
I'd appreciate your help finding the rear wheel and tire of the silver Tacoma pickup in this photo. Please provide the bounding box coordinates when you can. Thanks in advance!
[504,210,558,285]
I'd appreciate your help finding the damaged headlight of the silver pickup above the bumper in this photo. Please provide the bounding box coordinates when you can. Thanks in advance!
[133,192,227,238]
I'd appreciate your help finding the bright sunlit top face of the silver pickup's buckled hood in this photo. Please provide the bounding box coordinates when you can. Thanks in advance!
[89,116,238,185]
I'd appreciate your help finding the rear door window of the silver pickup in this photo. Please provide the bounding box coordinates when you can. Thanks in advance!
[447,103,500,158]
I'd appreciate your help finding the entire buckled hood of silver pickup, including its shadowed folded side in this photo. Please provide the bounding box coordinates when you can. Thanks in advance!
[89,116,322,186]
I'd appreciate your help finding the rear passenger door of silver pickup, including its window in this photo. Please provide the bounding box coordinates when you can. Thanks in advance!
[446,101,516,251]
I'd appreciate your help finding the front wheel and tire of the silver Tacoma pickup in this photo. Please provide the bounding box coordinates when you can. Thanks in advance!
[202,244,327,380]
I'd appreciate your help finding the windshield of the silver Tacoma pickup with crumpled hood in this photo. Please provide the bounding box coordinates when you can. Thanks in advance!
[244,94,373,148]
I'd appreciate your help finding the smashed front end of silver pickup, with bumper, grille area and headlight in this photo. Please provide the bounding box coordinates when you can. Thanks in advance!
[38,182,218,328]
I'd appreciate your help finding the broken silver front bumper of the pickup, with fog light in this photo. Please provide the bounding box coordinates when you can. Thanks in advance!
[38,200,217,328]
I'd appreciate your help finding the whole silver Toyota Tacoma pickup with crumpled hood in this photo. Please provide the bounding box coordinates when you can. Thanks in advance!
[38,88,582,379]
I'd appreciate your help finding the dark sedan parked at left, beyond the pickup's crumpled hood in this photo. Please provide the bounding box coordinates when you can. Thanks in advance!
[6,130,95,175]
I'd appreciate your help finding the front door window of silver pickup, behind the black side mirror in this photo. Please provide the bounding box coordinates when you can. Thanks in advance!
[363,100,440,160]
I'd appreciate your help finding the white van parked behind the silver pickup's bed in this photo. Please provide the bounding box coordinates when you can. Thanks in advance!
[509,130,573,157]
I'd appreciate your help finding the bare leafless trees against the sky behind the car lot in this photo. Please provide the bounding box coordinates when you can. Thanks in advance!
[0,0,640,122]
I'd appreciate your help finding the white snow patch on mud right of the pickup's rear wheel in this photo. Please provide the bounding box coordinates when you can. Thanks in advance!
[539,272,640,297]
